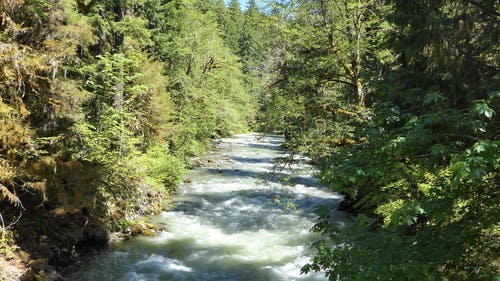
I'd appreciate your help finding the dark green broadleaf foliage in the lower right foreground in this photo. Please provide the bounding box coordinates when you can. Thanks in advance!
[304,77,500,280]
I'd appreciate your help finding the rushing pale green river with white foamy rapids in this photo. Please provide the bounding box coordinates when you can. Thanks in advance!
[71,134,347,281]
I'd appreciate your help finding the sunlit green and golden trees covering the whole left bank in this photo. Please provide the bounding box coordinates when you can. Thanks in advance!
[0,0,257,260]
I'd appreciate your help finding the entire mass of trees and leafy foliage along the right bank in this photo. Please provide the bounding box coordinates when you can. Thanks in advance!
[260,0,500,280]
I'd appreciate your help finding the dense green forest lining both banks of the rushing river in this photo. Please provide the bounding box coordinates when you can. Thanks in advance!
[0,0,500,280]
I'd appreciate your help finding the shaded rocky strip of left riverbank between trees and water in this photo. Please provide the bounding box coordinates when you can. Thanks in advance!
[0,137,239,281]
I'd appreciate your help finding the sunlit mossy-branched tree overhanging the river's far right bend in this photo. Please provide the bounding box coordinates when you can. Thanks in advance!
[260,1,391,158]
